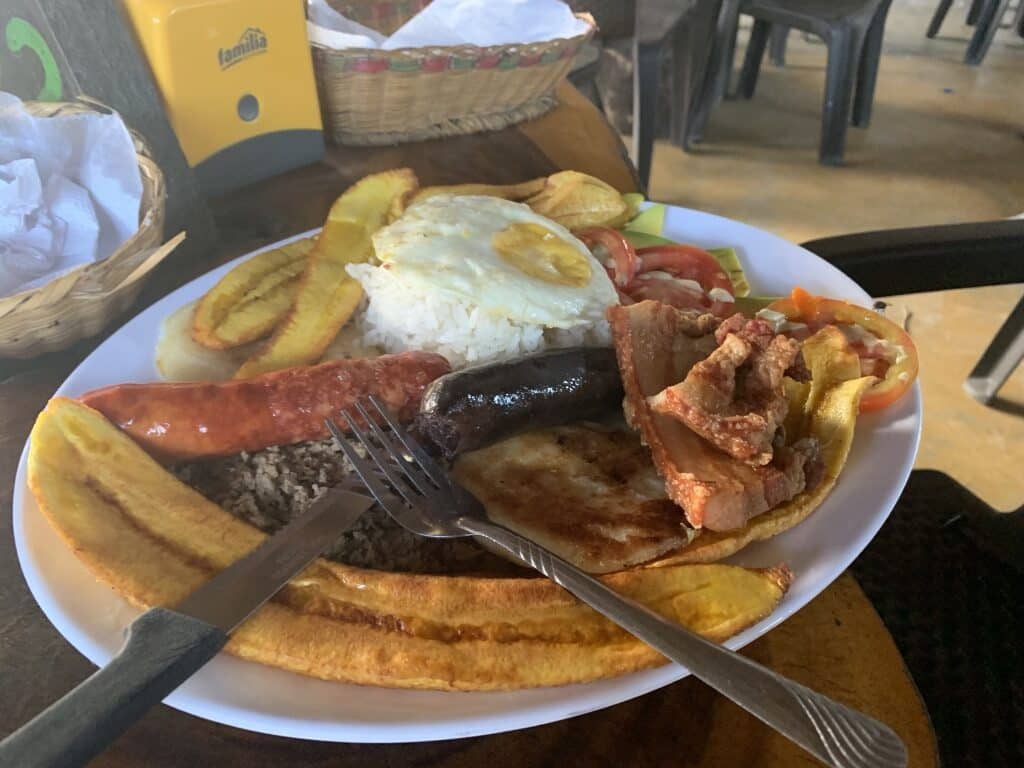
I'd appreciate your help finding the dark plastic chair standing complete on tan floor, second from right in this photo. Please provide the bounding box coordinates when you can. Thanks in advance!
[728,0,892,165]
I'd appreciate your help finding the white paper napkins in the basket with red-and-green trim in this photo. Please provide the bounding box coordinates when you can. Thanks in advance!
[309,0,587,50]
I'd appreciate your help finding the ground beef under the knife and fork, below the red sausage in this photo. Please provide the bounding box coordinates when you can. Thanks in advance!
[171,440,523,575]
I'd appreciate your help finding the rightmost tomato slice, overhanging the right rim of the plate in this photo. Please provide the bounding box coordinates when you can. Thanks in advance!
[768,288,919,413]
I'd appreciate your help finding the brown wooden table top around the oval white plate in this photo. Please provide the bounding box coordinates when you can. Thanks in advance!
[0,86,937,768]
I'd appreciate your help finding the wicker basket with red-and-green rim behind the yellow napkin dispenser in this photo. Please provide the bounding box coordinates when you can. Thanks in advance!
[312,0,596,144]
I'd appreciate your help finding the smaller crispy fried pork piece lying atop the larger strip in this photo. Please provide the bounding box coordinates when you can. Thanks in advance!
[647,314,800,465]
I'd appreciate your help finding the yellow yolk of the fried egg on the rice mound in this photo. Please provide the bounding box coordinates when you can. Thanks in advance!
[490,222,591,288]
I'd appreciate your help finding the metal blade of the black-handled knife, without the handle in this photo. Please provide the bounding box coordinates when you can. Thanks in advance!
[174,487,374,633]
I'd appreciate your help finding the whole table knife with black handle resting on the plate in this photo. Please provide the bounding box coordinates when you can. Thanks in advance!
[0,488,374,768]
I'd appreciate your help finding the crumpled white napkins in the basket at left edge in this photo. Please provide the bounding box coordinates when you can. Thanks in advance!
[0,91,142,296]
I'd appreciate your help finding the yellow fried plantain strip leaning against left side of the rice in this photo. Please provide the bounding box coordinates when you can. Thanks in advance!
[234,168,418,379]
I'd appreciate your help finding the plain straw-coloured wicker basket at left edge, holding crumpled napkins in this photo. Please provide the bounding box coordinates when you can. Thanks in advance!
[0,99,175,357]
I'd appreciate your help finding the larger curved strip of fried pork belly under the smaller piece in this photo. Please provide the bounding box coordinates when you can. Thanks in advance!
[608,301,816,530]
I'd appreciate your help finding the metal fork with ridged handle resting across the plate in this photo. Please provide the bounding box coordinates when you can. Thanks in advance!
[326,397,907,768]
